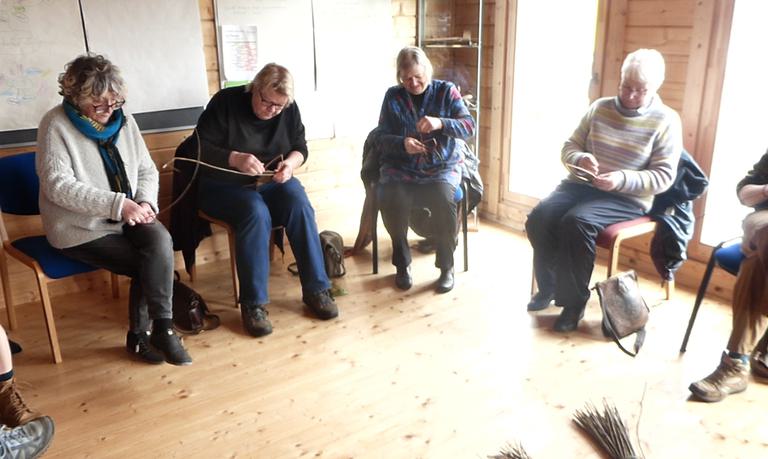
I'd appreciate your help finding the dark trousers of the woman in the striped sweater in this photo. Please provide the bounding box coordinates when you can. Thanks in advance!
[525,181,644,310]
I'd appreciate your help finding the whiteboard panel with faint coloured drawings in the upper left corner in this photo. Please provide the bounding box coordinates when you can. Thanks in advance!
[0,0,85,131]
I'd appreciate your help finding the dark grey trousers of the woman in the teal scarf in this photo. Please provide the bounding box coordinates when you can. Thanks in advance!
[61,221,173,333]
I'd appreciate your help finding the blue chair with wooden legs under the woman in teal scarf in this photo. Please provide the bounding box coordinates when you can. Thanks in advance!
[0,152,119,363]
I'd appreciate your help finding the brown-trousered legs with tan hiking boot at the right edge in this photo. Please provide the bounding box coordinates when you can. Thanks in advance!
[689,227,768,402]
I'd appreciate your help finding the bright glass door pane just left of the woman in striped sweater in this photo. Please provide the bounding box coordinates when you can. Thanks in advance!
[509,0,598,198]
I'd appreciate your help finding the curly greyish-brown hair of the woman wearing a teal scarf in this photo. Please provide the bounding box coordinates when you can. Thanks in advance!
[59,54,125,105]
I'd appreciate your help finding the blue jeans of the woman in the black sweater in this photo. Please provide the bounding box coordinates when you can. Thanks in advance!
[198,177,331,305]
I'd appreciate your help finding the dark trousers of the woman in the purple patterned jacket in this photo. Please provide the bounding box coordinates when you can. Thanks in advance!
[378,182,457,269]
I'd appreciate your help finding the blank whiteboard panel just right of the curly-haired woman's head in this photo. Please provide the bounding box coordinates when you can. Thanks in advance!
[81,0,208,113]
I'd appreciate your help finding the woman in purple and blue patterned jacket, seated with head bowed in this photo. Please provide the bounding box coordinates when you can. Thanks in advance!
[378,46,475,293]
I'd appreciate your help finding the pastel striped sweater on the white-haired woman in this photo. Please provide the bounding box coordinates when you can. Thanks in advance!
[561,95,683,211]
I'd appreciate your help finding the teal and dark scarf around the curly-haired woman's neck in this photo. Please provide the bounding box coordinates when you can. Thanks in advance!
[63,100,133,199]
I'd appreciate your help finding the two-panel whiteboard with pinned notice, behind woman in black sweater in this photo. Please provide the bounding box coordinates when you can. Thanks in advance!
[216,0,395,139]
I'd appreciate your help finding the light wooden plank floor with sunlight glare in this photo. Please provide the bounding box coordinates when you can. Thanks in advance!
[6,221,768,458]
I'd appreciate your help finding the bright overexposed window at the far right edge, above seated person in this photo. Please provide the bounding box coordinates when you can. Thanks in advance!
[701,0,768,245]
